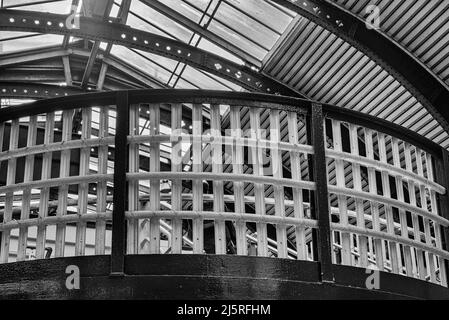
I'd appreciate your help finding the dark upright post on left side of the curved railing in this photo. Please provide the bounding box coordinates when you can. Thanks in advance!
[111,91,129,276]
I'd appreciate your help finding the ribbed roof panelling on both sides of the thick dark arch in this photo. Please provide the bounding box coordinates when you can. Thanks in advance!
[264,1,449,148]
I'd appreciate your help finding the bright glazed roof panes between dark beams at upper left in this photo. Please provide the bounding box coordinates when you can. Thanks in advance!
[0,0,294,91]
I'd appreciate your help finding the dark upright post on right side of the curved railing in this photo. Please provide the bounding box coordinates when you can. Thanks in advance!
[311,103,335,282]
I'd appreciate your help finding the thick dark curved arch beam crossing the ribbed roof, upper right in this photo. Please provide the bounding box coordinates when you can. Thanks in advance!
[272,0,449,132]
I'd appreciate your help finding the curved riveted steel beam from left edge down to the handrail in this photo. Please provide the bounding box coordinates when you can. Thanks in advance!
[0,9,303,97]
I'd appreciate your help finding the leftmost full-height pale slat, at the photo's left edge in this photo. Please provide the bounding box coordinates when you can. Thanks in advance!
[0,119,20,263]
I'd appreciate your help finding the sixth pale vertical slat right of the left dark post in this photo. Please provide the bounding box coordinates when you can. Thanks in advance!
[230,106,247,255]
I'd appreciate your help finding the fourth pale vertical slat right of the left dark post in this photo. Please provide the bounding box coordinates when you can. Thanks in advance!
[192,103,204,254]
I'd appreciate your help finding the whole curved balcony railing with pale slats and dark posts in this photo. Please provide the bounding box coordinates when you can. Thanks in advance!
[0,90,449,286]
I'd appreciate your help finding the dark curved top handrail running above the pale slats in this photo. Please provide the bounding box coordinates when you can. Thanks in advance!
[0,89,441,153]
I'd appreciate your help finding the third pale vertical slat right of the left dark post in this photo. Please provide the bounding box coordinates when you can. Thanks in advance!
[171,103,182,254]
